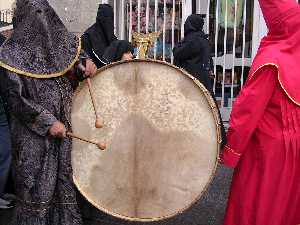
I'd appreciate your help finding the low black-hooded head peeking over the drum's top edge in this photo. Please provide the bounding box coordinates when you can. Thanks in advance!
[103,40,134,63]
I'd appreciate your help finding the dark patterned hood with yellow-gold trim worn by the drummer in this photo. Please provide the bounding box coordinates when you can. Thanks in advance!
[0,0,80,78]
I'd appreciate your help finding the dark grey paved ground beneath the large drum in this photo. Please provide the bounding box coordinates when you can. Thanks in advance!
[0,166,232,225]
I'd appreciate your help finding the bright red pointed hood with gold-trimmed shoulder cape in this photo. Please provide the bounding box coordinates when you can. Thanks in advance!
[249,0,300,106]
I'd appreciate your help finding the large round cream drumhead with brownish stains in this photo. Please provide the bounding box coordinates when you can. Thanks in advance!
[72,60,220,221]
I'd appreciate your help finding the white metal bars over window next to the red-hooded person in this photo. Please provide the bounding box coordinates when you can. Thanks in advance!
[196,0,254,120]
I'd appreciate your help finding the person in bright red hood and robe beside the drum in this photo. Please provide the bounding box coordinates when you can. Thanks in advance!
[221,0,300,225]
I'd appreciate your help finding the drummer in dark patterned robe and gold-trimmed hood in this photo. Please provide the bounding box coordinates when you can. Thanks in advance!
[0,0,96,225]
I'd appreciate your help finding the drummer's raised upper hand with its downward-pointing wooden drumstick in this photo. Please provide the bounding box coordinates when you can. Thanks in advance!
[78,59,103,128]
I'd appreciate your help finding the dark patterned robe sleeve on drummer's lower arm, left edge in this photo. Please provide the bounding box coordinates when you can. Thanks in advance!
[1,72,57,136]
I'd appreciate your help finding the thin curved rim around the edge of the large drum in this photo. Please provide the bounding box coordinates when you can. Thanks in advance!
[72,59,222,222]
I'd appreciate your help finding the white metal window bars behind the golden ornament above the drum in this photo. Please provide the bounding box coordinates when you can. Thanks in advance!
[116,0,184,62]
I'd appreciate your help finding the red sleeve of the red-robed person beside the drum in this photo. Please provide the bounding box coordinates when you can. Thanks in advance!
[220,66,278,168]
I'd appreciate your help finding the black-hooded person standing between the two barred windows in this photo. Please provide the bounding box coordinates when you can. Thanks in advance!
[173,14,212,91]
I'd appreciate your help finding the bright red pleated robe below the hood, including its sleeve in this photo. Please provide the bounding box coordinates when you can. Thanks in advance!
[221,65,300,225]
